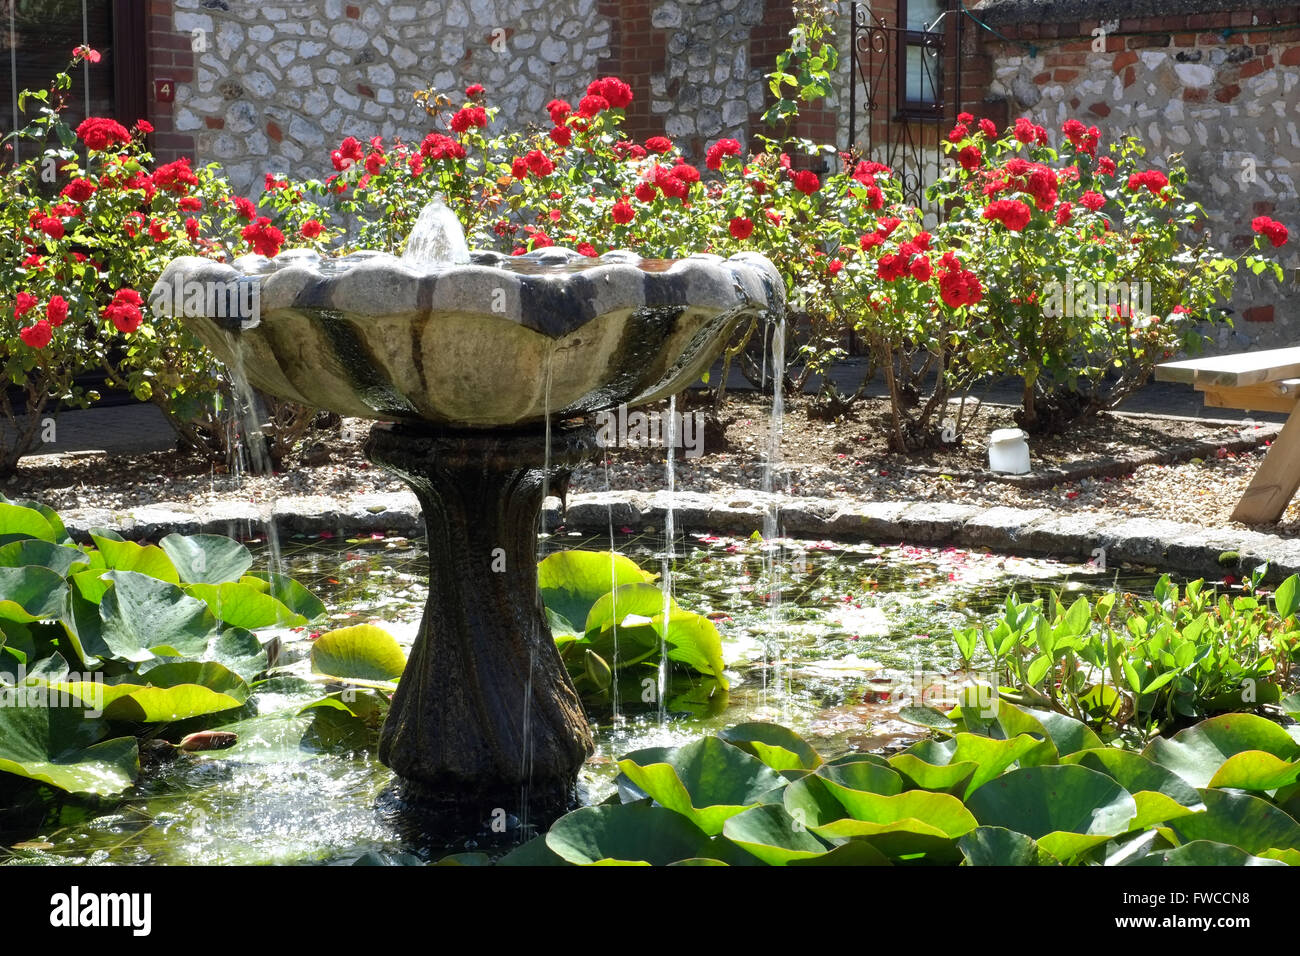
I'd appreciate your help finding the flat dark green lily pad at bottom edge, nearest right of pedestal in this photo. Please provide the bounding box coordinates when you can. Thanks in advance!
[546,801,709,866]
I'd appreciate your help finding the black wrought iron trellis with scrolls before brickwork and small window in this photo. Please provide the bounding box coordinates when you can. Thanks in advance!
[849,0,962,208]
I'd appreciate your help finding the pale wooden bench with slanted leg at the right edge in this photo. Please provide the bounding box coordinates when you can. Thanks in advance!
[1156,349,1300,524]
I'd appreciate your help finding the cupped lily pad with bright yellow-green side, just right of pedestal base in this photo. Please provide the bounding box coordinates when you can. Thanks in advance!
[619,736,785,835]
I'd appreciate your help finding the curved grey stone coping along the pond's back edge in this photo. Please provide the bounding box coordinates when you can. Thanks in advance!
[62,490,1300,579]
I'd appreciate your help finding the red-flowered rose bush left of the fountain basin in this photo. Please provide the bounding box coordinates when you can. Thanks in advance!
[0,47,323,472]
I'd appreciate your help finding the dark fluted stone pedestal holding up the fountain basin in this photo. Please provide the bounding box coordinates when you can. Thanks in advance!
[365,425,598,819]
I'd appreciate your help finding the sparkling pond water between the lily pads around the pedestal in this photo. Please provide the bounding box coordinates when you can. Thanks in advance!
[0,535,1156,864]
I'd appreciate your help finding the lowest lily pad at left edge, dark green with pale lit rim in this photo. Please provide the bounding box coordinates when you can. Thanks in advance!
[0,705,140,796]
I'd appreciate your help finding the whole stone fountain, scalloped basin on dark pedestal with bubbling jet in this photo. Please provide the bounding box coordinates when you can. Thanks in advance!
[151,207,784,819]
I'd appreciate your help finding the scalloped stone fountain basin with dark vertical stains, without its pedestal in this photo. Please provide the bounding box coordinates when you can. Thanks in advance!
[150,248,784,428]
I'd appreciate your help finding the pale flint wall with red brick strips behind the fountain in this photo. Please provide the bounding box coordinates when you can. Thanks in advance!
[148,0,811,193]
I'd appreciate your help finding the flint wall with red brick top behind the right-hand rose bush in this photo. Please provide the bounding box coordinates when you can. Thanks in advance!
[975,0,1300,350]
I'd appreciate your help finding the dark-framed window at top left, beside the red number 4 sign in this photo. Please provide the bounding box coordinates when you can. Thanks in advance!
[0,0,144,158]
